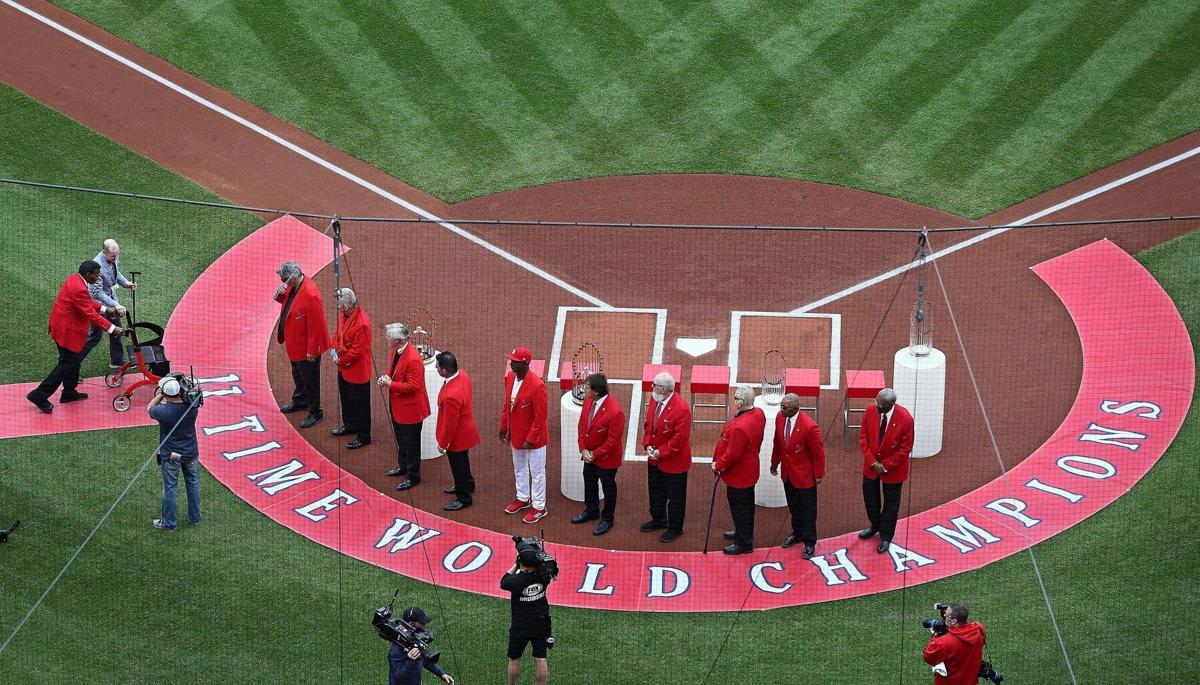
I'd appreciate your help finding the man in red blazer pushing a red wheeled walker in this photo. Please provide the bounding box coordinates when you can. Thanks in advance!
[25,259,125,414]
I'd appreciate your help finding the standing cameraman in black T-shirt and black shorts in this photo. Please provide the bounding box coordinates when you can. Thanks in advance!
[500,542,554,685]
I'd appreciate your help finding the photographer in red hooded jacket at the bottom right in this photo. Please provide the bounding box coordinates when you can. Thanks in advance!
[920,603,1004,685]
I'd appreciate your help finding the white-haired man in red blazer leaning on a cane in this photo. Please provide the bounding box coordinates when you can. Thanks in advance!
[713,385,767,554]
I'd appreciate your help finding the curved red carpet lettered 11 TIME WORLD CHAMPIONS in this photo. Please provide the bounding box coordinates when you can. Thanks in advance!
[154,217,1195,612]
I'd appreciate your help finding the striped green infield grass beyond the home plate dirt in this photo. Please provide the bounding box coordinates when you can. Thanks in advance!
[49,0,1200,217]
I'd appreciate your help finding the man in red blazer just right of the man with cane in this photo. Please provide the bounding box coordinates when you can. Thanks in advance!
[770,392,824,559]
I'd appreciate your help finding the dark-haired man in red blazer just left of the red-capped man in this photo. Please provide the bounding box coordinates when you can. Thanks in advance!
[434,351,479,511]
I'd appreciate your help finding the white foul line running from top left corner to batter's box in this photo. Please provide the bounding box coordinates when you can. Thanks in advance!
[0,0,610,310]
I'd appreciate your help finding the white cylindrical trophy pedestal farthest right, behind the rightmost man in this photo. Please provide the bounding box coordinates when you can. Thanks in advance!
[892,348,946,458]
